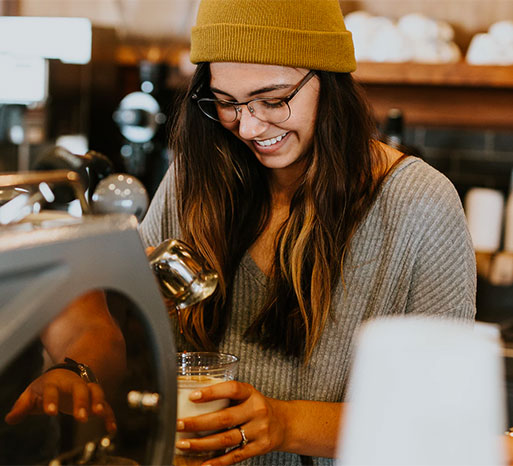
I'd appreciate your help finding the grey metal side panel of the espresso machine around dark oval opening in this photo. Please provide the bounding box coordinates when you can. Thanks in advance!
[0,209,176,464]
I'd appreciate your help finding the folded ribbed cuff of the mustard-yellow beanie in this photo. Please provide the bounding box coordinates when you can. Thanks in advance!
[191,24,356,73]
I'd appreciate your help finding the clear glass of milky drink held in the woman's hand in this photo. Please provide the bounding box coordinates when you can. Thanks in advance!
[174,352,239,466]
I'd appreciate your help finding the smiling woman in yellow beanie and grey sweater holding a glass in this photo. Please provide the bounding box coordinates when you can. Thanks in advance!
[141,0,475,466]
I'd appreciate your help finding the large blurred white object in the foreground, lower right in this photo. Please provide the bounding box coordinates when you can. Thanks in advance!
[338,317,505,466]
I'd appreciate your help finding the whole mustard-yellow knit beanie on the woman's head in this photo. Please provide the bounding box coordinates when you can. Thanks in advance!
[191,0,356,73]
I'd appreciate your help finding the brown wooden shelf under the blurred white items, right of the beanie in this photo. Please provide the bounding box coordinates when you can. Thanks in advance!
[354,63,513,130]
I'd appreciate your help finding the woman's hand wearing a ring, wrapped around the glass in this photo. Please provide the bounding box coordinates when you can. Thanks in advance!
[176,381,287,466]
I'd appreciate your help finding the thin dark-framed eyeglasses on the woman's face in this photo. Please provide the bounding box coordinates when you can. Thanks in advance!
[192,71,315,124]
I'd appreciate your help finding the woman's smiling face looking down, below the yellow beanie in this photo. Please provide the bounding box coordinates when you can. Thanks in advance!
[210,63,319,177]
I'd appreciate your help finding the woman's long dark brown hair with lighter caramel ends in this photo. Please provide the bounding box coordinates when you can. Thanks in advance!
[172,63,385,361]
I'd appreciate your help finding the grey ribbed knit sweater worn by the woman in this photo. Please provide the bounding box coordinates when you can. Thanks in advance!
[140,157,476,466]
